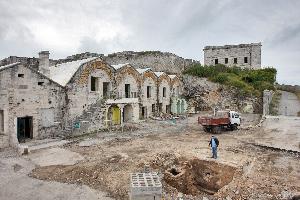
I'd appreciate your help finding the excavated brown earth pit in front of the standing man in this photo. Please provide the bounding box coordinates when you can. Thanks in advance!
[164,158,236,195]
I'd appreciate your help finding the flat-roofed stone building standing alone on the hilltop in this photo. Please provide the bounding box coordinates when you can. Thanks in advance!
[203,43,261,69]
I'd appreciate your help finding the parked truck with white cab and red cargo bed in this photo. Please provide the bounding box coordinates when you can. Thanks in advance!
[198,111,241,133]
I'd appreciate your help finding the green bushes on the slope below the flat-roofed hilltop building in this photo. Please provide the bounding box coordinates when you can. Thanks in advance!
[184,64,277,96]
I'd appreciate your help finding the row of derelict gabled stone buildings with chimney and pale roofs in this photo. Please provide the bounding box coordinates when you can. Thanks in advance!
[0,51,187,148]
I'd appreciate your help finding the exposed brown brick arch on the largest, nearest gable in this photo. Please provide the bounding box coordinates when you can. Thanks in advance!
[78,61,113,84]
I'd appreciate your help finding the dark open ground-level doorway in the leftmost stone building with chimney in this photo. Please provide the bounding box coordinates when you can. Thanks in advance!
[17,117,33,143]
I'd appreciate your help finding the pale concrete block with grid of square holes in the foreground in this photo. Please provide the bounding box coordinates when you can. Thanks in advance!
[129,172,162,200]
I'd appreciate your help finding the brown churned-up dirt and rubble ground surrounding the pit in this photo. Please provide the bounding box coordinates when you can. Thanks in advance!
[5,115,290,199]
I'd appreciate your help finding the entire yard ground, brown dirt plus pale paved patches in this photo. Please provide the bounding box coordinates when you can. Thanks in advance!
[0,113,300,200]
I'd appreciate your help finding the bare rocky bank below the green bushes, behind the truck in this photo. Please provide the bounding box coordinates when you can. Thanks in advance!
[183,75,262,113]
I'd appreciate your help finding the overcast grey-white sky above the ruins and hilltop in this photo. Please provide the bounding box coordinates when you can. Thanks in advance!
[0,0,300,85]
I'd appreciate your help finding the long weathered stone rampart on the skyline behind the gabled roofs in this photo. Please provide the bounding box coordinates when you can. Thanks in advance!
[0,51,200,74]
